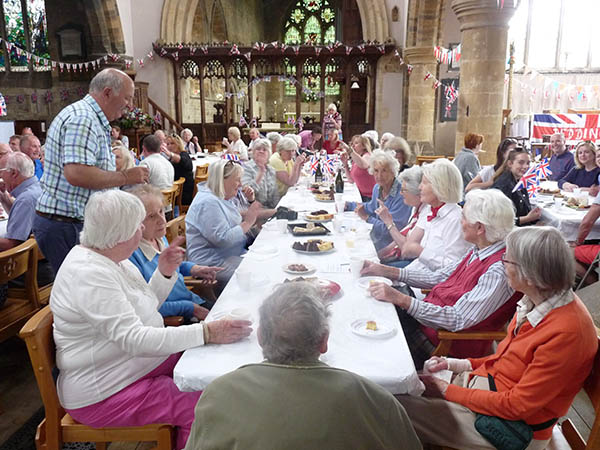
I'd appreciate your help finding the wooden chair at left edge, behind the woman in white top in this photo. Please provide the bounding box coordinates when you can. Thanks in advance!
[0,239,40,342]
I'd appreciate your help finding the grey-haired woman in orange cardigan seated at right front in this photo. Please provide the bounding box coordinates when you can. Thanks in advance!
[397,227,598,450]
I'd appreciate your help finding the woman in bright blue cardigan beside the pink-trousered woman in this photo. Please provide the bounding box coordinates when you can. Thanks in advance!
[129,184,221,321]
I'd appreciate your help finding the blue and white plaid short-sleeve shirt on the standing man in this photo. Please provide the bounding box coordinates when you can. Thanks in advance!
[36,95,115,220]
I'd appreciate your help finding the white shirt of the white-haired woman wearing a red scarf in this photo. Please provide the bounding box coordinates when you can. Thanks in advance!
[406,203,472,271]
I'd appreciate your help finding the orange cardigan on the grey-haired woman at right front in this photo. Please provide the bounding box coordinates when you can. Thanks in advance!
[446,296,598,440]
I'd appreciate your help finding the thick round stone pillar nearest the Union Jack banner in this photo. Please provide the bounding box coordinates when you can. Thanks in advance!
[452,0,515,164]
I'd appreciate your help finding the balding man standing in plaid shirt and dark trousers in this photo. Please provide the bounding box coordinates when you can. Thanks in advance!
[33,69,148,272]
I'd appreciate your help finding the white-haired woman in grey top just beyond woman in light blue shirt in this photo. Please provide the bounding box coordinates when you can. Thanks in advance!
[242,139,279,209]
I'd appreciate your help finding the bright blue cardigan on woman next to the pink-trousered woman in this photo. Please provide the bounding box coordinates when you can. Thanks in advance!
[129,237,204,320]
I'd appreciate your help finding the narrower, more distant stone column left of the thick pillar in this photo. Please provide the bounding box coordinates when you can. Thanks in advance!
[404,46,437,154]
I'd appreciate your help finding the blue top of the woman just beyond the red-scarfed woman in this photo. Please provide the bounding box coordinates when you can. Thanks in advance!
[347,179,412,250]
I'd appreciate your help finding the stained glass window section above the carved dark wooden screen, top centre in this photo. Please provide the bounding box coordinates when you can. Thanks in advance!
[283,0,336,45]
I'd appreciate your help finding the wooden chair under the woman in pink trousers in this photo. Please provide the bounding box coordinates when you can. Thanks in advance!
[19,306,174,450]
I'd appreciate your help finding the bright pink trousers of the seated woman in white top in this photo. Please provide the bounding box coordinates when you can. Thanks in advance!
[66,353,202,449]
